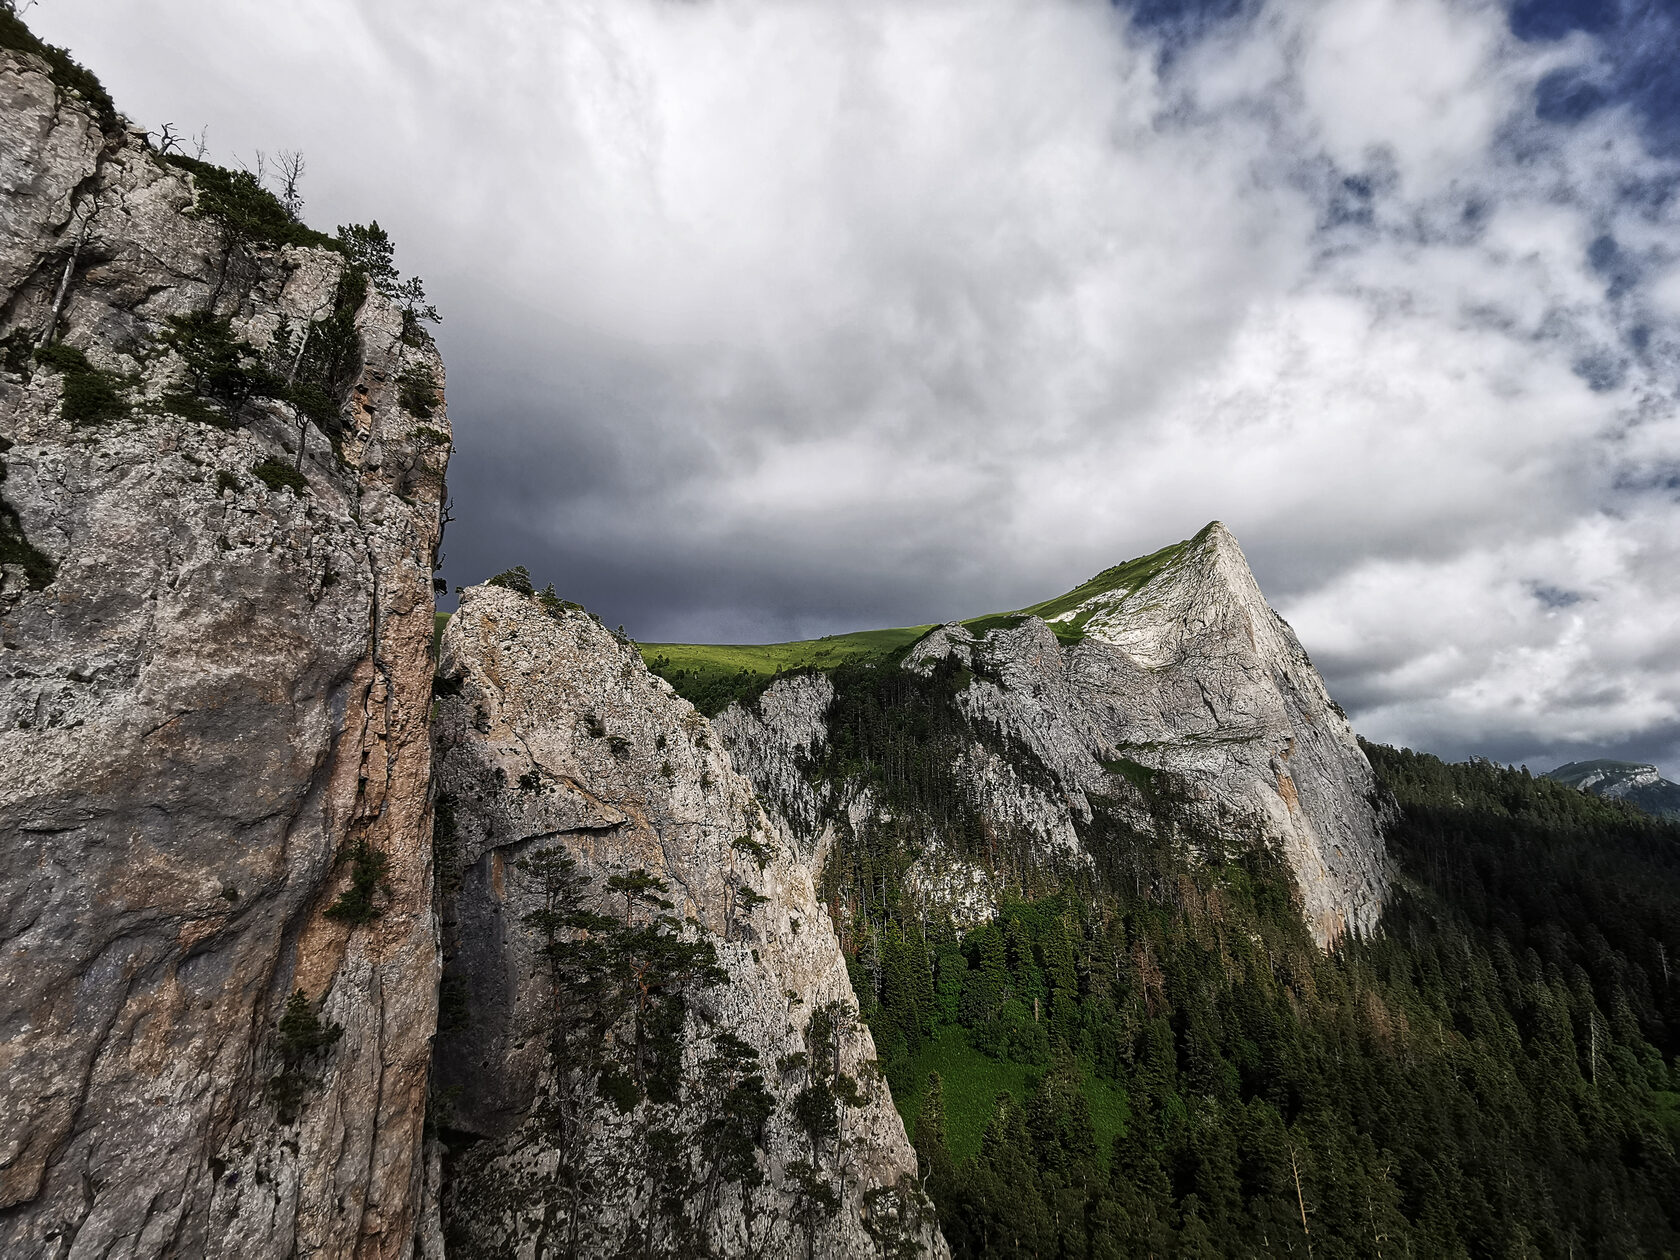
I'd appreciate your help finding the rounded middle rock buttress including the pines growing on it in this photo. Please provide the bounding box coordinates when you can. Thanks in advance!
[426,586,944,1257]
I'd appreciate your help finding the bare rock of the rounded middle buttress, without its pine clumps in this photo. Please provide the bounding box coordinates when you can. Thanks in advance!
[435,586,944,1257]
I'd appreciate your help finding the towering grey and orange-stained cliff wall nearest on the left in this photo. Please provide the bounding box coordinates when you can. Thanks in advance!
[0,44,449,1257]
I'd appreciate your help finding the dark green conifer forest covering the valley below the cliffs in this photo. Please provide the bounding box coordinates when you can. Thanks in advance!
[813,669,1680,1258]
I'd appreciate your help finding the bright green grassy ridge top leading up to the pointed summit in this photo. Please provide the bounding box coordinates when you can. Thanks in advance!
[638,524,1213,716]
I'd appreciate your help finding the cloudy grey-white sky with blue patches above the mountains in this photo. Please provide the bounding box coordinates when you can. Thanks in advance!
[29,0,1680,774]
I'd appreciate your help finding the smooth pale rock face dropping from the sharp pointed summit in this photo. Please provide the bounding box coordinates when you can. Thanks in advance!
[1068,521,1386,944]
